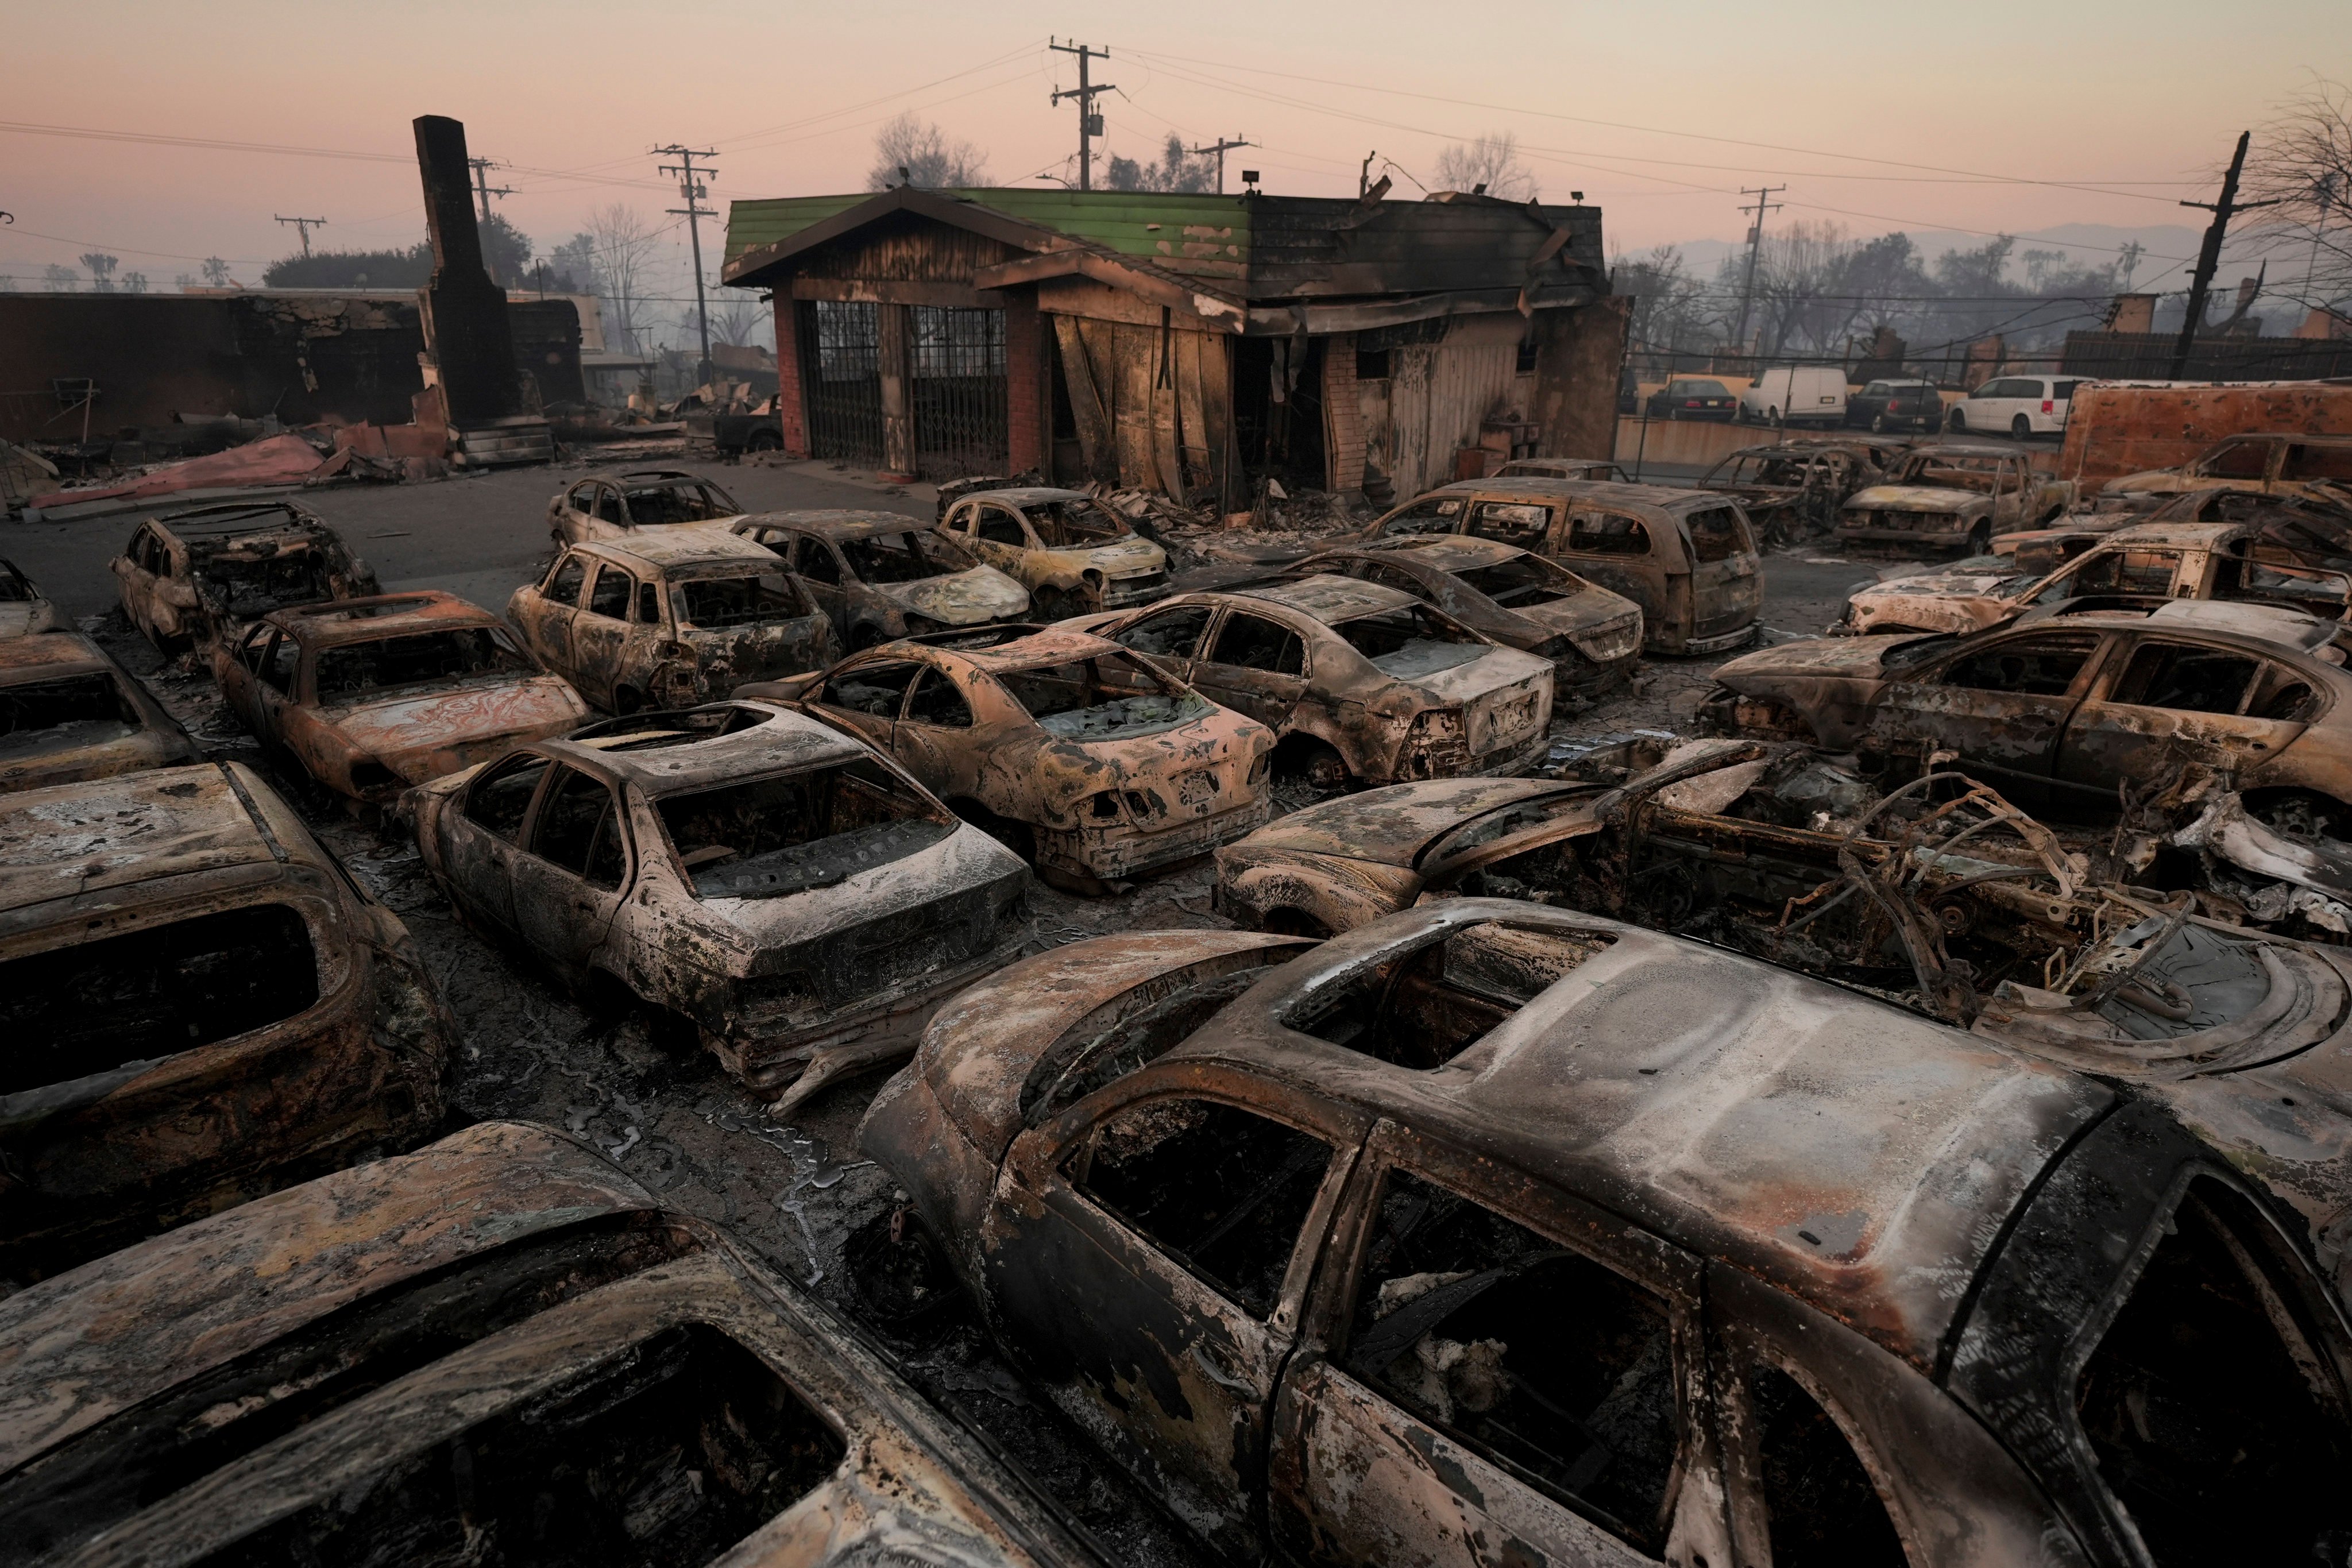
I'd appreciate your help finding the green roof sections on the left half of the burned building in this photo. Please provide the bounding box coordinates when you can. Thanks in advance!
[724,186,1249,277]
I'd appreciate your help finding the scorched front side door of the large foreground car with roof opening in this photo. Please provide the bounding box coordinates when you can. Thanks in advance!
[979,1060,1373,1547]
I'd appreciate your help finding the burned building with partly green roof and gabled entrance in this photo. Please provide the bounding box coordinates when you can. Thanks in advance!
[724,181,1625,510]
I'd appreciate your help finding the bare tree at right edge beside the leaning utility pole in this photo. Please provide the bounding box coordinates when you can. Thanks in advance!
[2239,80,2352,306]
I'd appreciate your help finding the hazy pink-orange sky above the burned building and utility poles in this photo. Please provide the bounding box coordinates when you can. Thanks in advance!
[0,0,2352,303]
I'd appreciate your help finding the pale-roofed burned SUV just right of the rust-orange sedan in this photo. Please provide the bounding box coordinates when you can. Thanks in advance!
[505,529,833,712]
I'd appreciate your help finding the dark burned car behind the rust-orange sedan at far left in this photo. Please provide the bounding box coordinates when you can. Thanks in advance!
[108,501,379,654]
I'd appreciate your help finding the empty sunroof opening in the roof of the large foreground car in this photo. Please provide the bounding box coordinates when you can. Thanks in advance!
[1282,921,1616,1069]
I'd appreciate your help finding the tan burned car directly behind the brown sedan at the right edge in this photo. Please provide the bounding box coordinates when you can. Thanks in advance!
[1837,522,2352,632]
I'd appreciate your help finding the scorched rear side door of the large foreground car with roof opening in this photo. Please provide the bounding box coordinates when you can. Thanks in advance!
[1268,1117,1733,1568]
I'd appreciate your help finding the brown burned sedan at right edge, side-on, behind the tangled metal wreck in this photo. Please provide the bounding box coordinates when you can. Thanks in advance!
[1701,604,2352,816]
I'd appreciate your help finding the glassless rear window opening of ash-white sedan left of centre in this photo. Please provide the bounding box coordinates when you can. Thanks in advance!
[659,759,955,898]
